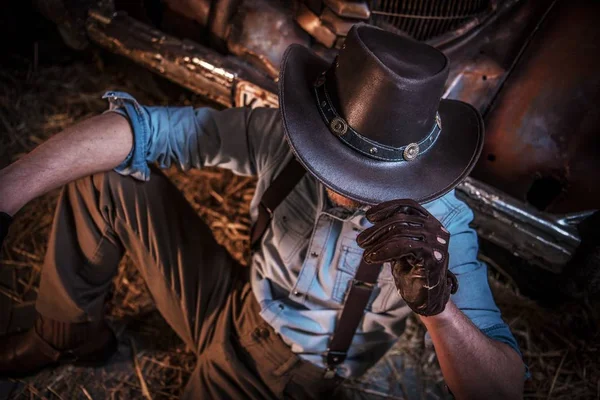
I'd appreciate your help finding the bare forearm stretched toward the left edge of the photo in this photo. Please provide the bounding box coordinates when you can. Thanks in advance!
[0,113,133,215]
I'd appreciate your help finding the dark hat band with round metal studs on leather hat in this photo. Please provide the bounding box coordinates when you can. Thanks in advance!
[314,69,442,161]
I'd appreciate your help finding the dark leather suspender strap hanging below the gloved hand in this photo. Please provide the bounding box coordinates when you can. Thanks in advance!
[324,259,382,379]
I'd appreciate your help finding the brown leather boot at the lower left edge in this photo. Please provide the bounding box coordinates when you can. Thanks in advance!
[0,315,117,377]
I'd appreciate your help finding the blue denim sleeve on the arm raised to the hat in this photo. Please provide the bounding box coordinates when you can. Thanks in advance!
[445,196,529,376]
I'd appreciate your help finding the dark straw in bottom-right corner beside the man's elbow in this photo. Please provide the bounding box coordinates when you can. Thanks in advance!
[490,277,600,399]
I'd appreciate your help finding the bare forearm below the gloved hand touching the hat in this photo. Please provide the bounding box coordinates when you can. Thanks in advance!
[421,301,525,399]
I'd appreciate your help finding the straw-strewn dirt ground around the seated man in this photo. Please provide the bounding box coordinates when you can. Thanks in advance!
[0,12,600,399]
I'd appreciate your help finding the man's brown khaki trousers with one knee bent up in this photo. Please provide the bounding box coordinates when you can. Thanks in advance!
[36,172,340,400]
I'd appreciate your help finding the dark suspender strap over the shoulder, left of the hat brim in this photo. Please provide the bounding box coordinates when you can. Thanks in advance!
[250,158,306,249]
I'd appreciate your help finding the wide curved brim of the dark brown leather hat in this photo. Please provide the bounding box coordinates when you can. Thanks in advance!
[279,45,483,204]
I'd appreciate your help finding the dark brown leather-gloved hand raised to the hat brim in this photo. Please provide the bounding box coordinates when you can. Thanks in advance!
[357,200,458,316]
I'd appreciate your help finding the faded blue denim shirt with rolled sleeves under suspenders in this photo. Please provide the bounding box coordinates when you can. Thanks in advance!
[105,92,519,377]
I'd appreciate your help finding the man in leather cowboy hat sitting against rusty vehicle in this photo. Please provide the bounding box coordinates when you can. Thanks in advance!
[0,25,524,399]
